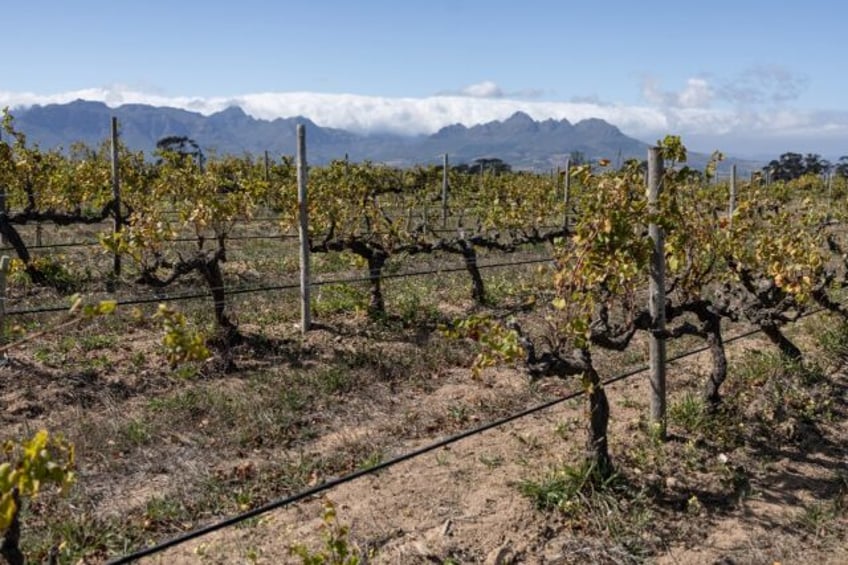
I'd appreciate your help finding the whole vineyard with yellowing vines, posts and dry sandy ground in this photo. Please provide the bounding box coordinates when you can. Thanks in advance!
[0,111,848,564]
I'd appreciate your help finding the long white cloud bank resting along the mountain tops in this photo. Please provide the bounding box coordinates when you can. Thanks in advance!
[0,72,848,155]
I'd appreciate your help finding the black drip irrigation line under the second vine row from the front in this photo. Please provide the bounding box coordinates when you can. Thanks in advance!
[2,253,551,316]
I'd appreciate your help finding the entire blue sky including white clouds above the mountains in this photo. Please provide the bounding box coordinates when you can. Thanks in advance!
[0,0,848,157]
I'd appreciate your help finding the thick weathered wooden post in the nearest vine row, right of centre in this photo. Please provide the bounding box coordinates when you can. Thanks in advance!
[648,147,666,439]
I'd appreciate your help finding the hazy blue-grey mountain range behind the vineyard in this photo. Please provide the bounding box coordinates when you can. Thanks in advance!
[4,100,748,171]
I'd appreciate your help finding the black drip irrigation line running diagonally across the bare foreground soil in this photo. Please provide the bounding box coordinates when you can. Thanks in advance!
[107,308,836,565]
